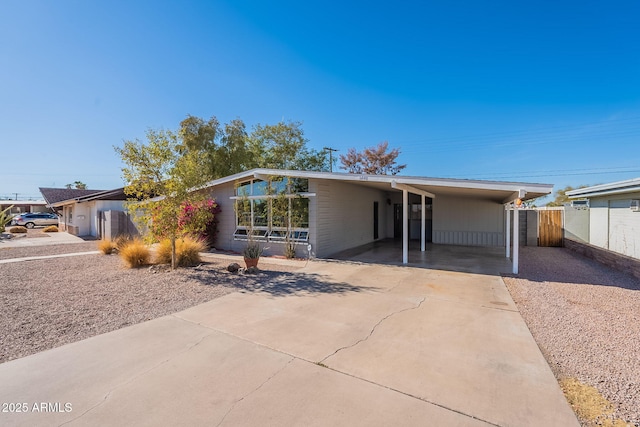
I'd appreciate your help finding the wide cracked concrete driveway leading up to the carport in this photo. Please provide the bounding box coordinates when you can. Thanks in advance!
[0,261,578,426]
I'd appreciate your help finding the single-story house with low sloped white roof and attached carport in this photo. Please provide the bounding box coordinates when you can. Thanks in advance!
[201,169,553,273]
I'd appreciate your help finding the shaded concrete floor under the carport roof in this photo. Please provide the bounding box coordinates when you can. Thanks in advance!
[327,239,512,276]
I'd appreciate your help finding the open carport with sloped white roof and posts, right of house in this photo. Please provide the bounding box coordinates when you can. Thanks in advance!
[310,174,553,274]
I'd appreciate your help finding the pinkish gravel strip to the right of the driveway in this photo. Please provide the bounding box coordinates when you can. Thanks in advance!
[504,247,640,426]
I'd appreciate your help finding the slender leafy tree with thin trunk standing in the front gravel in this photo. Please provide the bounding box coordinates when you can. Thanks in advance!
[114,129,213,268]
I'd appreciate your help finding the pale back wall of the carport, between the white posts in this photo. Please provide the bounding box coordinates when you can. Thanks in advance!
[433,196,505,246]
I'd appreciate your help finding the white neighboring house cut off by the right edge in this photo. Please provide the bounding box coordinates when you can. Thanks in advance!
[567,178,640,259]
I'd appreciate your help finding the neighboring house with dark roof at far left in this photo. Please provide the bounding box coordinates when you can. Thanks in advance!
[40,188,137,239]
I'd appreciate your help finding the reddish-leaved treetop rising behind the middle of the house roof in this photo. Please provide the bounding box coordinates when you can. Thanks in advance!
[340,141,407,175]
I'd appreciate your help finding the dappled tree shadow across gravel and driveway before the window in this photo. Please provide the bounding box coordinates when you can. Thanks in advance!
[181,262,376,296]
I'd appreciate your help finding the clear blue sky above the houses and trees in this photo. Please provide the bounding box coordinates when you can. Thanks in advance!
[0,0,640,203]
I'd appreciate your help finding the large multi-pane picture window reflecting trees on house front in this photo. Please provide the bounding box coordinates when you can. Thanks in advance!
[233,177,314,242]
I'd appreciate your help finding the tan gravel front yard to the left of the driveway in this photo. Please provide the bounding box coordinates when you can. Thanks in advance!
[0,246,297,363]
